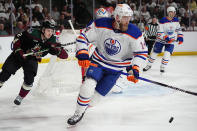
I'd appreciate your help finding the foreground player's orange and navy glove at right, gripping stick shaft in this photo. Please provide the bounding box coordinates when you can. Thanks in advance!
[127,65,139,83]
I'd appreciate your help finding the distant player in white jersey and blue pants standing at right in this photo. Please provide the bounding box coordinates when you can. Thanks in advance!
[143,6,183,73]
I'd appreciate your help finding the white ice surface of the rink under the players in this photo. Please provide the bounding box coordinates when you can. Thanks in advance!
[0,56,197,131]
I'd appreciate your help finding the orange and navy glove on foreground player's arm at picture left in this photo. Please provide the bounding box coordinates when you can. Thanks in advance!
[76,50,91,68]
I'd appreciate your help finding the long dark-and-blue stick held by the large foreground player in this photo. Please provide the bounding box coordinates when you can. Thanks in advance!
[90,63,197,96]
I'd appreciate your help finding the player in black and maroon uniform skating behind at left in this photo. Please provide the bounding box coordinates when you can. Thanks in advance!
[0,20,68,105]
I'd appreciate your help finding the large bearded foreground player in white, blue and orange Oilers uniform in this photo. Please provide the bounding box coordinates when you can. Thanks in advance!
[67,4,148,125]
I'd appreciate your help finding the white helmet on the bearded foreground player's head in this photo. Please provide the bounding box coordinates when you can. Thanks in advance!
[113,4,133,19]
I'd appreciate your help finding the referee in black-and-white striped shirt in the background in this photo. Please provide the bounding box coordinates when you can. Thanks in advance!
[144,16,159,55]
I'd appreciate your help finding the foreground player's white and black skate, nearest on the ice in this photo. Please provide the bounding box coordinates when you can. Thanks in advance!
[67,111,85,125]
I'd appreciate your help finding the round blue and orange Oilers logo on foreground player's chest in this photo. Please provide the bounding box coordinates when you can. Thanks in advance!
[104,38,121,56]
